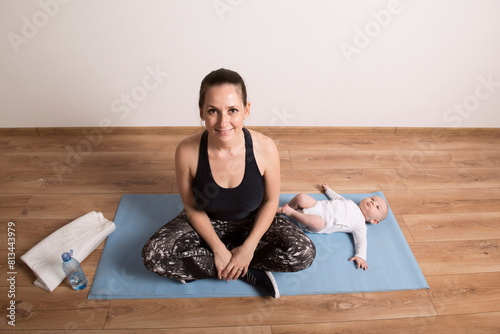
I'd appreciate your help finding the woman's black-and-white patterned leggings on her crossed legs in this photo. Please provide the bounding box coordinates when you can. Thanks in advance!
[142,210,316,280]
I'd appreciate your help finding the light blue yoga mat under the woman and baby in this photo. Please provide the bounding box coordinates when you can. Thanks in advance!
[88,192,429,299]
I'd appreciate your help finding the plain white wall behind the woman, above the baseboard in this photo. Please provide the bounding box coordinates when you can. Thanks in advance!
[0,0,500,127]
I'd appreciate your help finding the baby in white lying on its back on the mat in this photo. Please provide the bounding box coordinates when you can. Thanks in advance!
[278,183,389,270]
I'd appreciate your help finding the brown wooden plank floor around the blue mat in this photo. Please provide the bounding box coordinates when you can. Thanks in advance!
[0,128,500,334]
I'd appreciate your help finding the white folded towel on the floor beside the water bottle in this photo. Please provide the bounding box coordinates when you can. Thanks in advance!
[21,211,116,292]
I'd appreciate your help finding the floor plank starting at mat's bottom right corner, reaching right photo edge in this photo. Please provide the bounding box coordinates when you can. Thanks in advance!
[427,272,500,316]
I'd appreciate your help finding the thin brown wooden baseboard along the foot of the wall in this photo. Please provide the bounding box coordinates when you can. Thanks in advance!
[0,126,500,137]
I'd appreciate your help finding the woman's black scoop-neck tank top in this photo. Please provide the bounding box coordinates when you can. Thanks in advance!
[193,128,264,220]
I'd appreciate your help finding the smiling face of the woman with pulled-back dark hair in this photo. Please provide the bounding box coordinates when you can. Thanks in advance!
[200,84,250,142]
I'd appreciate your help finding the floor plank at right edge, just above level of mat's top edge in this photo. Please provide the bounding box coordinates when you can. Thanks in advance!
[398,168,500,189]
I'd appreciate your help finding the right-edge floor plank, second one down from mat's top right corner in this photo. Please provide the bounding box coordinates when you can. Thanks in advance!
[403,212,500,242]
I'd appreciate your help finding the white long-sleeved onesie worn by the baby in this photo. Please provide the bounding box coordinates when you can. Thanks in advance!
[299,189,367,261]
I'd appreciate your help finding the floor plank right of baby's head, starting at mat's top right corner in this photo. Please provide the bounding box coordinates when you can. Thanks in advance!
[383,188,500,215]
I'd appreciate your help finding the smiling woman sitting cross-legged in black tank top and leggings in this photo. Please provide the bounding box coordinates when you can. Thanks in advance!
[142,69,316,298]
